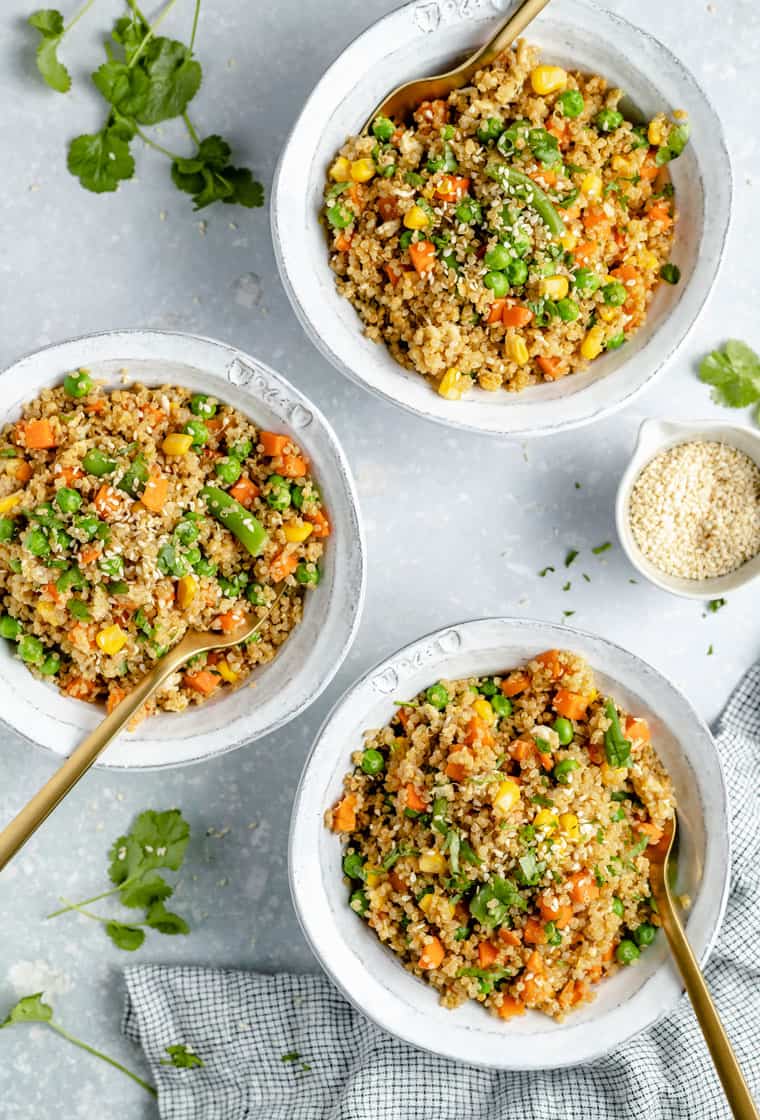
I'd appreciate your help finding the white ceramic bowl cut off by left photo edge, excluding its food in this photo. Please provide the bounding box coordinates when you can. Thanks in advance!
[0,330,365,768]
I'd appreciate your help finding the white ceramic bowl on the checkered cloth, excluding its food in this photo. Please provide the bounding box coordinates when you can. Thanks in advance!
[290,618,730,1070]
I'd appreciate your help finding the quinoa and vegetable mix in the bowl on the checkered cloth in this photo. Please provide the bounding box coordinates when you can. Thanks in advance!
[326,650,675,1019]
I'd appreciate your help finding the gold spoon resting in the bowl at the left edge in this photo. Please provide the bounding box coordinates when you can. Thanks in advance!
[0,582,285,870]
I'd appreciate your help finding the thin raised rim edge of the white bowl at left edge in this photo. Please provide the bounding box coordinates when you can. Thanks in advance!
[0,327,367,773]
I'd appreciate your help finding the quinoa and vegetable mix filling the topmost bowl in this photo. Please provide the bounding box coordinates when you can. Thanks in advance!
[325,41,688,400]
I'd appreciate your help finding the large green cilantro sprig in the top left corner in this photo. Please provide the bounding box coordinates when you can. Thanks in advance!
[29,0,264,209]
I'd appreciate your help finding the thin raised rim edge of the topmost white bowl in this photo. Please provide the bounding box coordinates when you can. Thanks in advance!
[270,0,733,440]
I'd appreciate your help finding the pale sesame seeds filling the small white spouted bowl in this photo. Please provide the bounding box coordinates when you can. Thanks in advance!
[628,440,760,579]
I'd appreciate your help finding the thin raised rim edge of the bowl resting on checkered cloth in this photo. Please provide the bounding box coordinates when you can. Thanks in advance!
[288,616,732,1072]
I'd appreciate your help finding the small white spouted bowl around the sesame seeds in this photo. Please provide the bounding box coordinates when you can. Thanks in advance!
[614,420,760,599]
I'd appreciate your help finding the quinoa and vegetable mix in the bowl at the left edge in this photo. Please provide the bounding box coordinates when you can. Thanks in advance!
[0,370,330,715]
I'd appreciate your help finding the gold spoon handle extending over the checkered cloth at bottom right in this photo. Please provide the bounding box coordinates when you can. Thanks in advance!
[657,893,760,1120]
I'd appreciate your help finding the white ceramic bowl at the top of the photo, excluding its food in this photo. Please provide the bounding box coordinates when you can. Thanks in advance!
[272,0,731,439]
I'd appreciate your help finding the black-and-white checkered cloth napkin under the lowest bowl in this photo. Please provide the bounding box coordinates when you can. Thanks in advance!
[124,664,760,1120]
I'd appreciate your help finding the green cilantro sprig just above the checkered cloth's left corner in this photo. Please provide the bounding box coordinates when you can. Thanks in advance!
[48,809,190,953]
